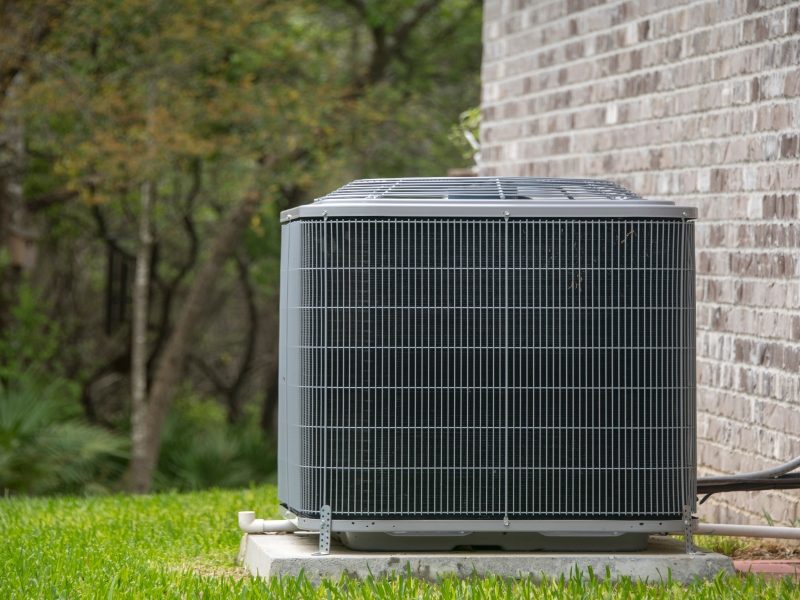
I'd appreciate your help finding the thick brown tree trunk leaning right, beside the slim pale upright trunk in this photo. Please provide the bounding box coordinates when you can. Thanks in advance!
[130,192,260,493]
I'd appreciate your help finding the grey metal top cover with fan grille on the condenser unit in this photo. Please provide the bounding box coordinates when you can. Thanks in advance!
[281,177,697,222]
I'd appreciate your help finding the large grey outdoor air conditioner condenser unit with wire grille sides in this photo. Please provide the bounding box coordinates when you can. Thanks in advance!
[279,177,696,550]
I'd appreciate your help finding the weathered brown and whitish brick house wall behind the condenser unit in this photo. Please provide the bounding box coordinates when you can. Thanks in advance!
[480,0,800,523]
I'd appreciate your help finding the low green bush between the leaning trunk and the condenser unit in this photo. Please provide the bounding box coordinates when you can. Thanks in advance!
[156,399,275,490]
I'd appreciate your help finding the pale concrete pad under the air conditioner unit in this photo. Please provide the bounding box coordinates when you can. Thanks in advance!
[240,533,733,583]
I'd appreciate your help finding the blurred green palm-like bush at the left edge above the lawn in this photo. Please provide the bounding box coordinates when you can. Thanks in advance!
[0,282,127,494]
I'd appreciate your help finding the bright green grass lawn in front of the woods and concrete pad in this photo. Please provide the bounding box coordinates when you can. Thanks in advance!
[0,486,800,599]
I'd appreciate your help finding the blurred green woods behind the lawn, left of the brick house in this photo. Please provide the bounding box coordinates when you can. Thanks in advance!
[0,0,481,493]
